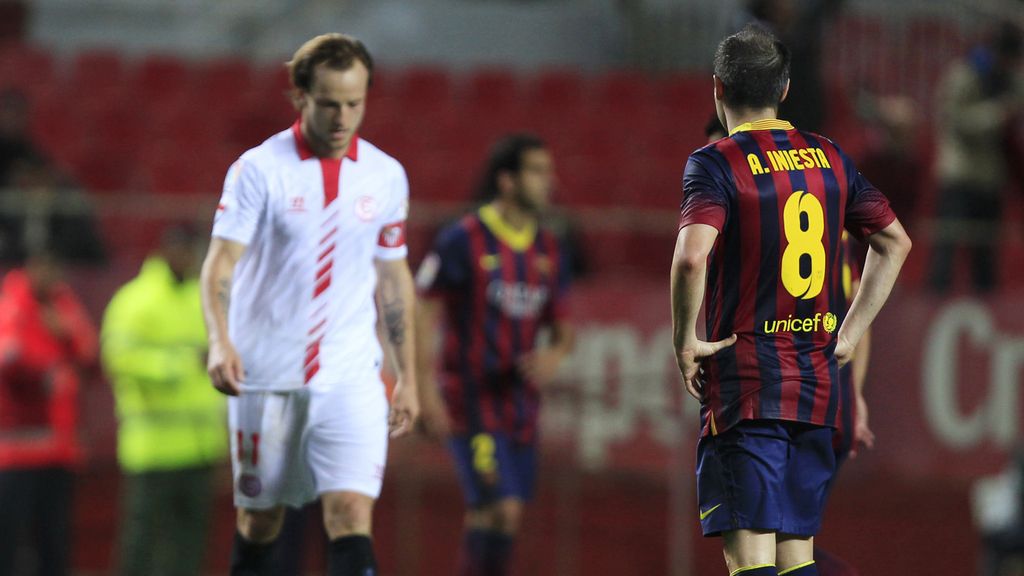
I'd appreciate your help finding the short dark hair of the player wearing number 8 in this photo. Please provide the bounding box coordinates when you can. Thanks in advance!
[715,24,790,109]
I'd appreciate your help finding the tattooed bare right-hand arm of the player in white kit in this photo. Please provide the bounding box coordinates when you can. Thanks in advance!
[376,258,420,438]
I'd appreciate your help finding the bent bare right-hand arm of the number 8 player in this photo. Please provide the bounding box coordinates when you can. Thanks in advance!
[836,220,911,366]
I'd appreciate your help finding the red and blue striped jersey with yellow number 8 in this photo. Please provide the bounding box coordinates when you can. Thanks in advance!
[679,120,896,435]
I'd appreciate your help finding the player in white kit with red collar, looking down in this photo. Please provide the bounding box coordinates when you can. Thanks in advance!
[202,34,419,576]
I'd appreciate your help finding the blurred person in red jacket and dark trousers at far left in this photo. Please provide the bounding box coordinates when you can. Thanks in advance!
[0,242,96,576]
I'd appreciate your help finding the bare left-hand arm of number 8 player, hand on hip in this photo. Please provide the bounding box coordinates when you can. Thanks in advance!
[671,224,736,401]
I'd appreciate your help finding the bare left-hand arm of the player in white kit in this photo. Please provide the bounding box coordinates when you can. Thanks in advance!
[200,238,246,396]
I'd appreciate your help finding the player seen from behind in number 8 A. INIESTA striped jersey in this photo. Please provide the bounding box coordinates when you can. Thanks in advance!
[672,27,910,576]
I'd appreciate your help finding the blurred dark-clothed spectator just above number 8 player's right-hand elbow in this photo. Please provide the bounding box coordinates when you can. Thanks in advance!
[858,96,926,222]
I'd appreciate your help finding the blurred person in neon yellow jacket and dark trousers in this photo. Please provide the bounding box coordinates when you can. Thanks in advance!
[102,228,227,576]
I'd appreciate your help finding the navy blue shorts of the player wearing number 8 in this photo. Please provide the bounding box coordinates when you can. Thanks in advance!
[697,420,836,536]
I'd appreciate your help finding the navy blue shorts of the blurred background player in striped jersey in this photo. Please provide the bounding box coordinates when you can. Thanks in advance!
[449,433,537,508]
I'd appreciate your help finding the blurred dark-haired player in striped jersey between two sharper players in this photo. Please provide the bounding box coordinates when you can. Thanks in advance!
[417,134,573,576]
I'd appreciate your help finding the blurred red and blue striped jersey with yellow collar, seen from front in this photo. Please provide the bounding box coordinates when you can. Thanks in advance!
[417,206,568,442]
